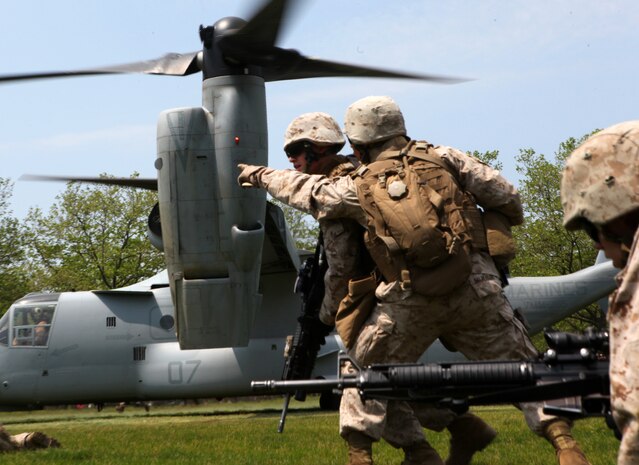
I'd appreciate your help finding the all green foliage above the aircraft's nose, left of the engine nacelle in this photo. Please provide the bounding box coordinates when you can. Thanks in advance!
[0,174,164,314]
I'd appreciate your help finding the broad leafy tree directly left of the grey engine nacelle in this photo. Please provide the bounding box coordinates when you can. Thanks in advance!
[27,174,164,291]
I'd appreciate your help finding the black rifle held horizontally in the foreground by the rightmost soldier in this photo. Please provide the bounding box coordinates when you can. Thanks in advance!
[251,330,612,427]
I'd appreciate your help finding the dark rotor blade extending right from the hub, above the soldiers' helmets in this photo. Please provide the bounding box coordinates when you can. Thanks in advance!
[262,49,472,84]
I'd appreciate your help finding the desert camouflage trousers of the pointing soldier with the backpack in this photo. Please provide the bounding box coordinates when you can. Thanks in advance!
[340,274,556,447]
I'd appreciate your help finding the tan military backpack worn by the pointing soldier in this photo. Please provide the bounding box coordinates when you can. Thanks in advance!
[351,141,483,296]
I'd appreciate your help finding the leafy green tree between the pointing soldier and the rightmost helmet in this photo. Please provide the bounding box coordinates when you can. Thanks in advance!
[510,134,605,330]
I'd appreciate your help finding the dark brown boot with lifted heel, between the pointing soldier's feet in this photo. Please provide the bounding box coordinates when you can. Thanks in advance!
[446,413,497,465]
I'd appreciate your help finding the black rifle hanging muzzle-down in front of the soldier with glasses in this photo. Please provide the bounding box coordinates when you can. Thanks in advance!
[277,232,333,433]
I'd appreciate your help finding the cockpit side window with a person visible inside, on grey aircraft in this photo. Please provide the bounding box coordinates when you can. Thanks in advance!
[11,303,56,347]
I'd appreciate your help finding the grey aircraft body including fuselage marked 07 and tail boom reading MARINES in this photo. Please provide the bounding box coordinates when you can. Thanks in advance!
[0,243,616,407]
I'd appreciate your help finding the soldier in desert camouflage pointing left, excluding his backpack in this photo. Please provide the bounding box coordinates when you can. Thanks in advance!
[238,97,588,465]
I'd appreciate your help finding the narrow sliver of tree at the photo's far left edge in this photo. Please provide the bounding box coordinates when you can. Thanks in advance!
[0,178,29,315]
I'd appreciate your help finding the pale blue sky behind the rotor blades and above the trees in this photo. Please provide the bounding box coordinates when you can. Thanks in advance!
[0,0,639,218]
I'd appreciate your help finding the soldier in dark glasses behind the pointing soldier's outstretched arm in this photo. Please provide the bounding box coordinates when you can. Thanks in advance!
[284,112,496,464]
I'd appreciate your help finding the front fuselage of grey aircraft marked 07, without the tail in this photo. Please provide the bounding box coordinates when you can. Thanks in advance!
[0,274,341,406]
